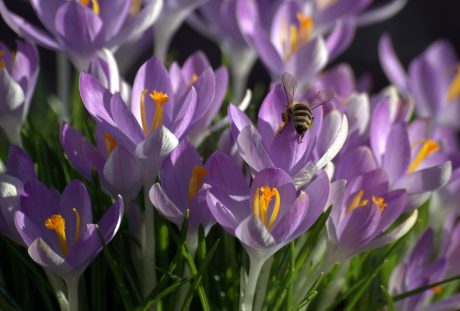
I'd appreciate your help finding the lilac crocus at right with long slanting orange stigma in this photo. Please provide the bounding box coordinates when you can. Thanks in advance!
[370,101,452,208]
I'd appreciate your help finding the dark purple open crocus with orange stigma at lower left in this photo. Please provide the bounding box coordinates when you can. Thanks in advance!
[14,179,123,281]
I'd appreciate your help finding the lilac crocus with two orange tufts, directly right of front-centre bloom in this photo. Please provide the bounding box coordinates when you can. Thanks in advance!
[327,169,417,264]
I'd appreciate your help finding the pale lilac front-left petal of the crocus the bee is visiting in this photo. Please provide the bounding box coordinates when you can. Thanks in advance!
[237,126,273,172]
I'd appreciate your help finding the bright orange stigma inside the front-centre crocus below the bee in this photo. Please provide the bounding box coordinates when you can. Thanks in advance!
[253,186,281,230]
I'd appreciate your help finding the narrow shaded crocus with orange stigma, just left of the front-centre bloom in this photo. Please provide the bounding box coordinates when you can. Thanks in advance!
[149,140,215,252]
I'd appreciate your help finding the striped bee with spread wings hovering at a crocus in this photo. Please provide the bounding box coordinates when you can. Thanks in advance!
[276,72,334,144]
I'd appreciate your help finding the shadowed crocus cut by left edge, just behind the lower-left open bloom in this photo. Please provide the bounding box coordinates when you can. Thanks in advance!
[0,145,37,243]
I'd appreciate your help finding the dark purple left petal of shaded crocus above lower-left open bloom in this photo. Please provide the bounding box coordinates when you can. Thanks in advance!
[60,122,104,180]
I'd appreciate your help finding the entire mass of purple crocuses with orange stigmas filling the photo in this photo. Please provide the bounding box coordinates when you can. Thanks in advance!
[0,0,460,310]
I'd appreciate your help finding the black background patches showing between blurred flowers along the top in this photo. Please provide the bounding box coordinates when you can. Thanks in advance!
[0,0,460,91]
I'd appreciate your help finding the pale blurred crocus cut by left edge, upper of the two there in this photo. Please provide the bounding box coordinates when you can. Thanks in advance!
[0,41,39,144]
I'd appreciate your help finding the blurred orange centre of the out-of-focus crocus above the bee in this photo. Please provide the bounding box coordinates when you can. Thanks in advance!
[281,12,313,61]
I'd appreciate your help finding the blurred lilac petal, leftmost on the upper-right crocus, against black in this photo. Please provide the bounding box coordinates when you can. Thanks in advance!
[379,34,408,91]
